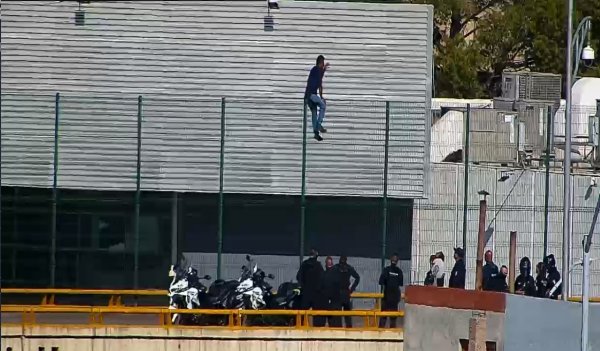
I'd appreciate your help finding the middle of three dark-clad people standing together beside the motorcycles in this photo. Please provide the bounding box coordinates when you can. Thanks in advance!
[319,256,342,328]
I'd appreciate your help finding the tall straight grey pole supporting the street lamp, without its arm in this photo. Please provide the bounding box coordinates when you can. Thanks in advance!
[562,0,573,301]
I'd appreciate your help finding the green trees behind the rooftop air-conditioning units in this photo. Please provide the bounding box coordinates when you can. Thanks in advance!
[418,0,600,97]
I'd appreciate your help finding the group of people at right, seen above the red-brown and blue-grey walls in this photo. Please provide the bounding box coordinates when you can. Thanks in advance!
[425,248,562,299]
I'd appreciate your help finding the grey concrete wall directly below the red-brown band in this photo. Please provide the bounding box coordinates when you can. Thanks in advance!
[404,304,505,351]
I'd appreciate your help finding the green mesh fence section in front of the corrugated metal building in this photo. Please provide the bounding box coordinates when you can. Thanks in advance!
[2,93,428,291]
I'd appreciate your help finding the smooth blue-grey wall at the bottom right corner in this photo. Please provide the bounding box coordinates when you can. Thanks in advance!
[504,295,600,351]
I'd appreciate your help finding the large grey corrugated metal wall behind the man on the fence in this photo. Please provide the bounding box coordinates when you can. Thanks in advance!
[2,1,432,198]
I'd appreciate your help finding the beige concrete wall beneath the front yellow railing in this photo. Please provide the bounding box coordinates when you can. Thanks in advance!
[1,326,403,351]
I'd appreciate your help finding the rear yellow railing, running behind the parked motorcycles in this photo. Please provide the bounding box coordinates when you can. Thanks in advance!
[0,288,392,310]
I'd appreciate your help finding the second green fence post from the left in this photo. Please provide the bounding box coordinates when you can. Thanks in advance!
[133,95,142,289]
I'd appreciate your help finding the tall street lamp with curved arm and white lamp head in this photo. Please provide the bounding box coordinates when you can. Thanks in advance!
[562,7,594,301]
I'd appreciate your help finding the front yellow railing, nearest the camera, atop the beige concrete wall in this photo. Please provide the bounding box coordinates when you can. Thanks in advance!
[1,305,404,331]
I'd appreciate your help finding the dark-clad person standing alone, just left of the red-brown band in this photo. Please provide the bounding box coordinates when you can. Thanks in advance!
[379,254,404,328]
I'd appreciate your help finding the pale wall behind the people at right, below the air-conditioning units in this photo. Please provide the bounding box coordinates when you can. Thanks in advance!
[411,163,600,296]
